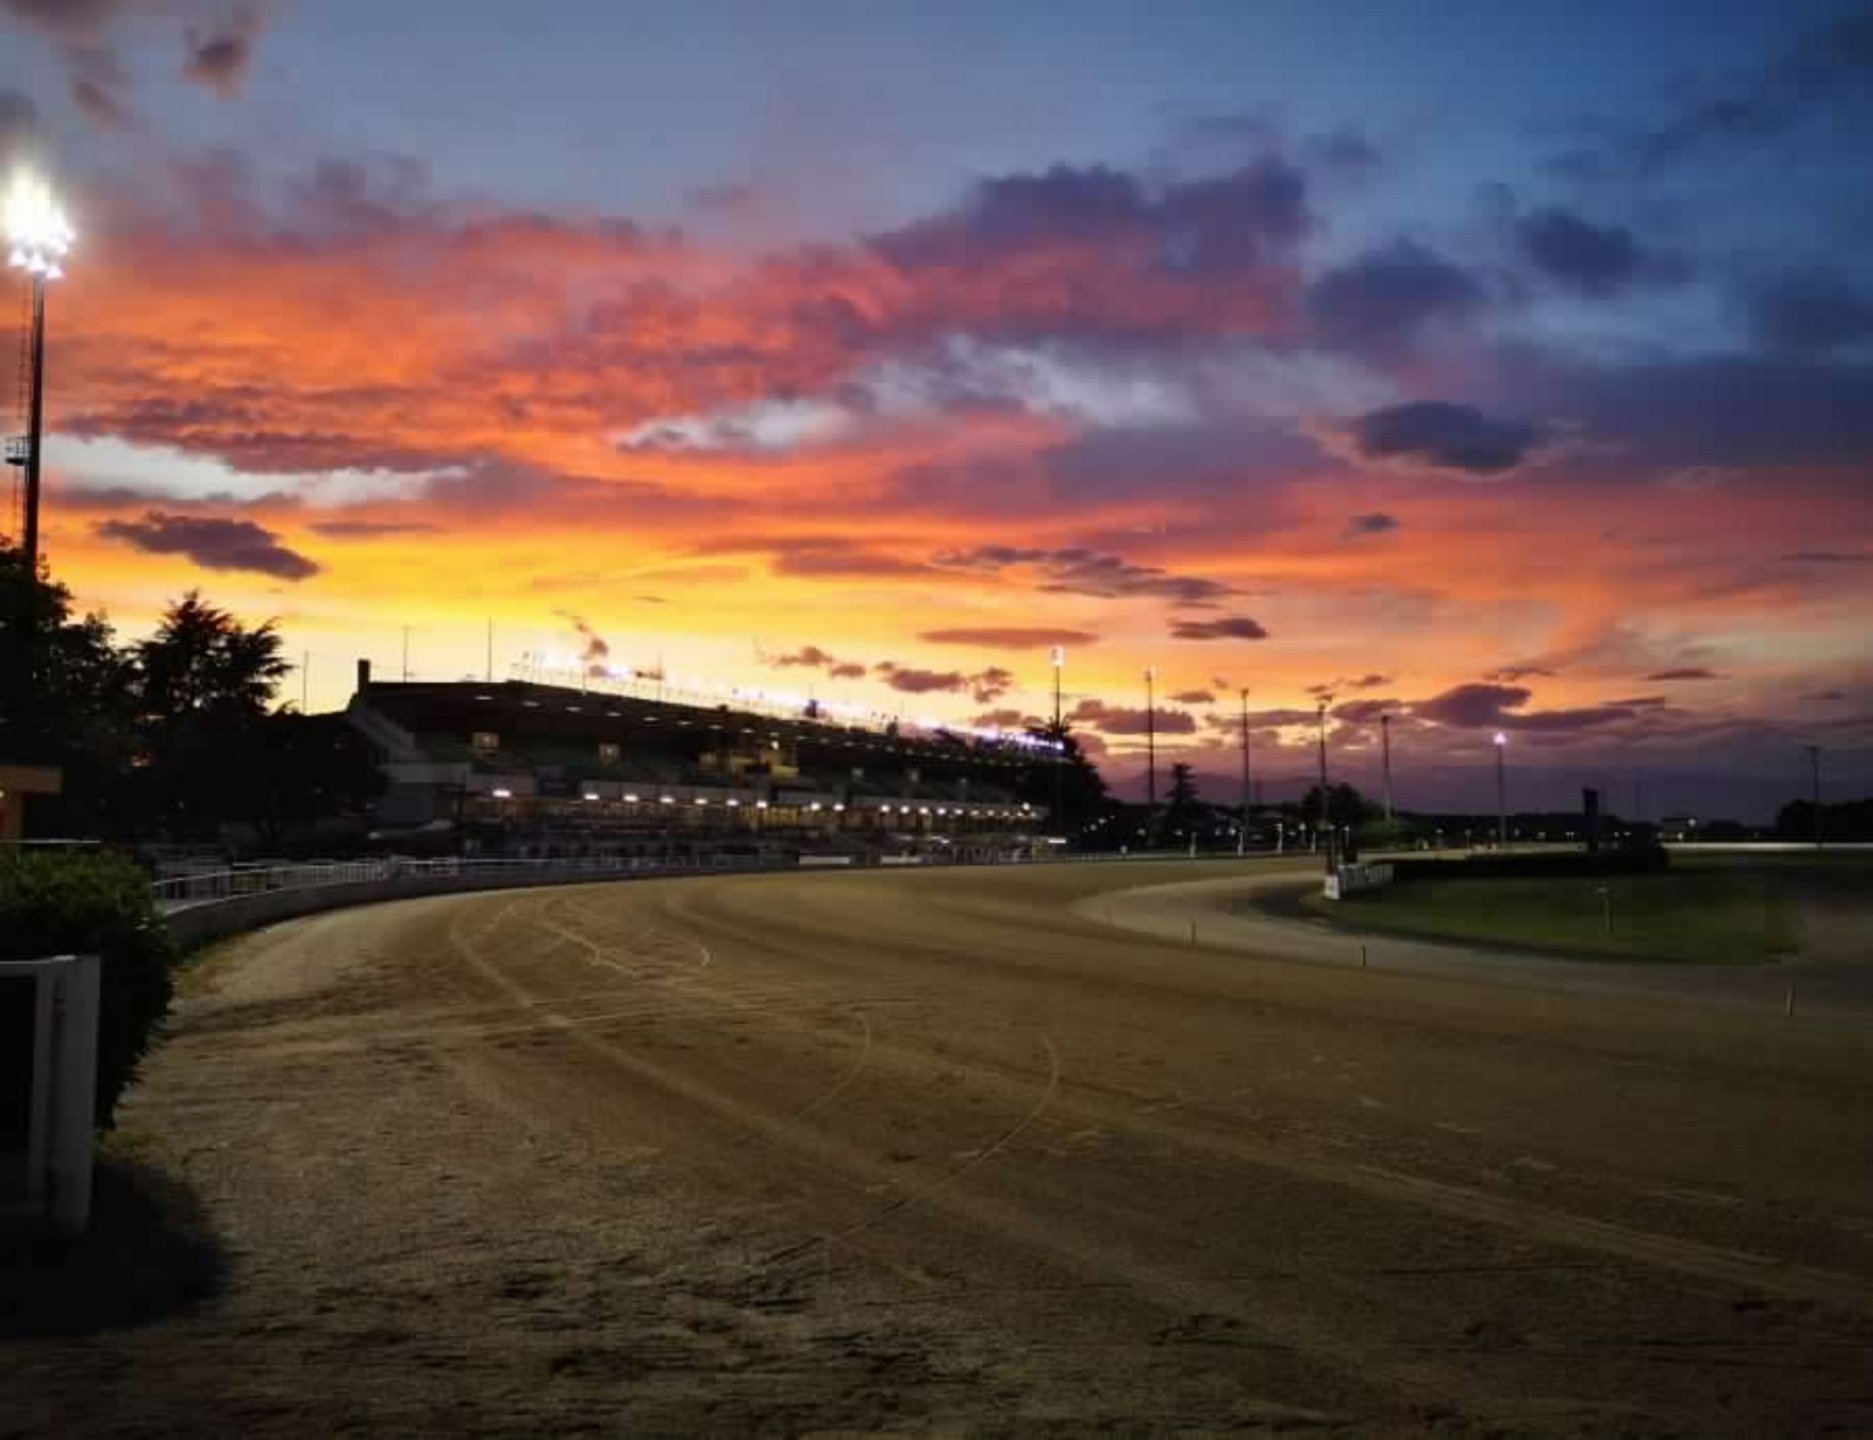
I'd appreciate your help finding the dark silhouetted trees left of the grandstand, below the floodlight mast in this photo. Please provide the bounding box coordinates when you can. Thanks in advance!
[0,539,382,846]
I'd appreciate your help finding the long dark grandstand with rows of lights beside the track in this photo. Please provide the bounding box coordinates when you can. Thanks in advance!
[345,661,1058,852]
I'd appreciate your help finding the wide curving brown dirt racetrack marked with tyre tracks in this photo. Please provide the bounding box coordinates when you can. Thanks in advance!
[11,865,1873,1436]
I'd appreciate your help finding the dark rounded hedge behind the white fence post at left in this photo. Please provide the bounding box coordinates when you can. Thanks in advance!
[0,850,176,1129]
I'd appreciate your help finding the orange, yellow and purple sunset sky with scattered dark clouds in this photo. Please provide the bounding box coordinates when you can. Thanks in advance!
[0,0,1873,818]
